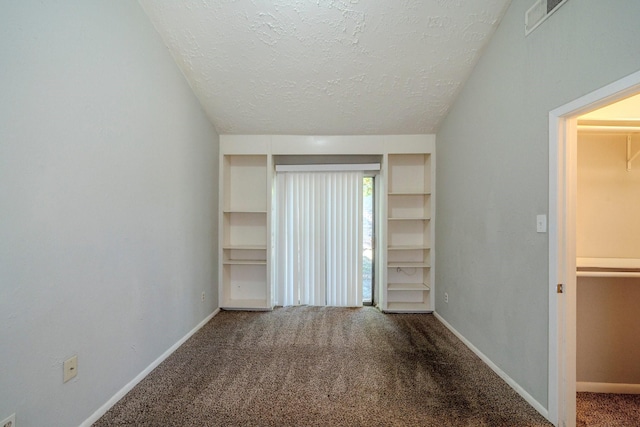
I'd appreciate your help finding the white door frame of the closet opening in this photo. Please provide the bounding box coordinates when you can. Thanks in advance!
[548,71,640,427]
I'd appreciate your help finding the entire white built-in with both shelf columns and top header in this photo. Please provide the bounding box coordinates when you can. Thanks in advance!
[218,135,435,313]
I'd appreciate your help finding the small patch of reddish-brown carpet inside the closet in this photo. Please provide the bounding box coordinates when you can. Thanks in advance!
[576,393,640,427]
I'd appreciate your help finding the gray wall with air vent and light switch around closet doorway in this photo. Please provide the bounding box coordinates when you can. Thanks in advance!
[435,0,640,407]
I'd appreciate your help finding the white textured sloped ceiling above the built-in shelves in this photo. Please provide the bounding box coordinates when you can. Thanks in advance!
[140,0,509,135]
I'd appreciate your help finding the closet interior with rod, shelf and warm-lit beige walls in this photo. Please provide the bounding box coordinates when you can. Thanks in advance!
[576,95,640,400]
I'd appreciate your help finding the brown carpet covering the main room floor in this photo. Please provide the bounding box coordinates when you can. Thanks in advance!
[94,307,551,427]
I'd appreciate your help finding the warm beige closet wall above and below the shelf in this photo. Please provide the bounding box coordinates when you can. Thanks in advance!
[576,134,640,384]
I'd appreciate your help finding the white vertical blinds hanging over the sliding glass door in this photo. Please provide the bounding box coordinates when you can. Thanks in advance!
[275,172,363,307]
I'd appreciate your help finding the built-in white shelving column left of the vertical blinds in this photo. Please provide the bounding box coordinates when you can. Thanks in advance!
[220,154,271,310]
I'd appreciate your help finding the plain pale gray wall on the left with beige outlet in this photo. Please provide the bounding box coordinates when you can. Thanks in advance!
[0,0,218,427]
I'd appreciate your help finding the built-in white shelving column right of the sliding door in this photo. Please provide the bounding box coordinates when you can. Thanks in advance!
[383,153,433,312]
